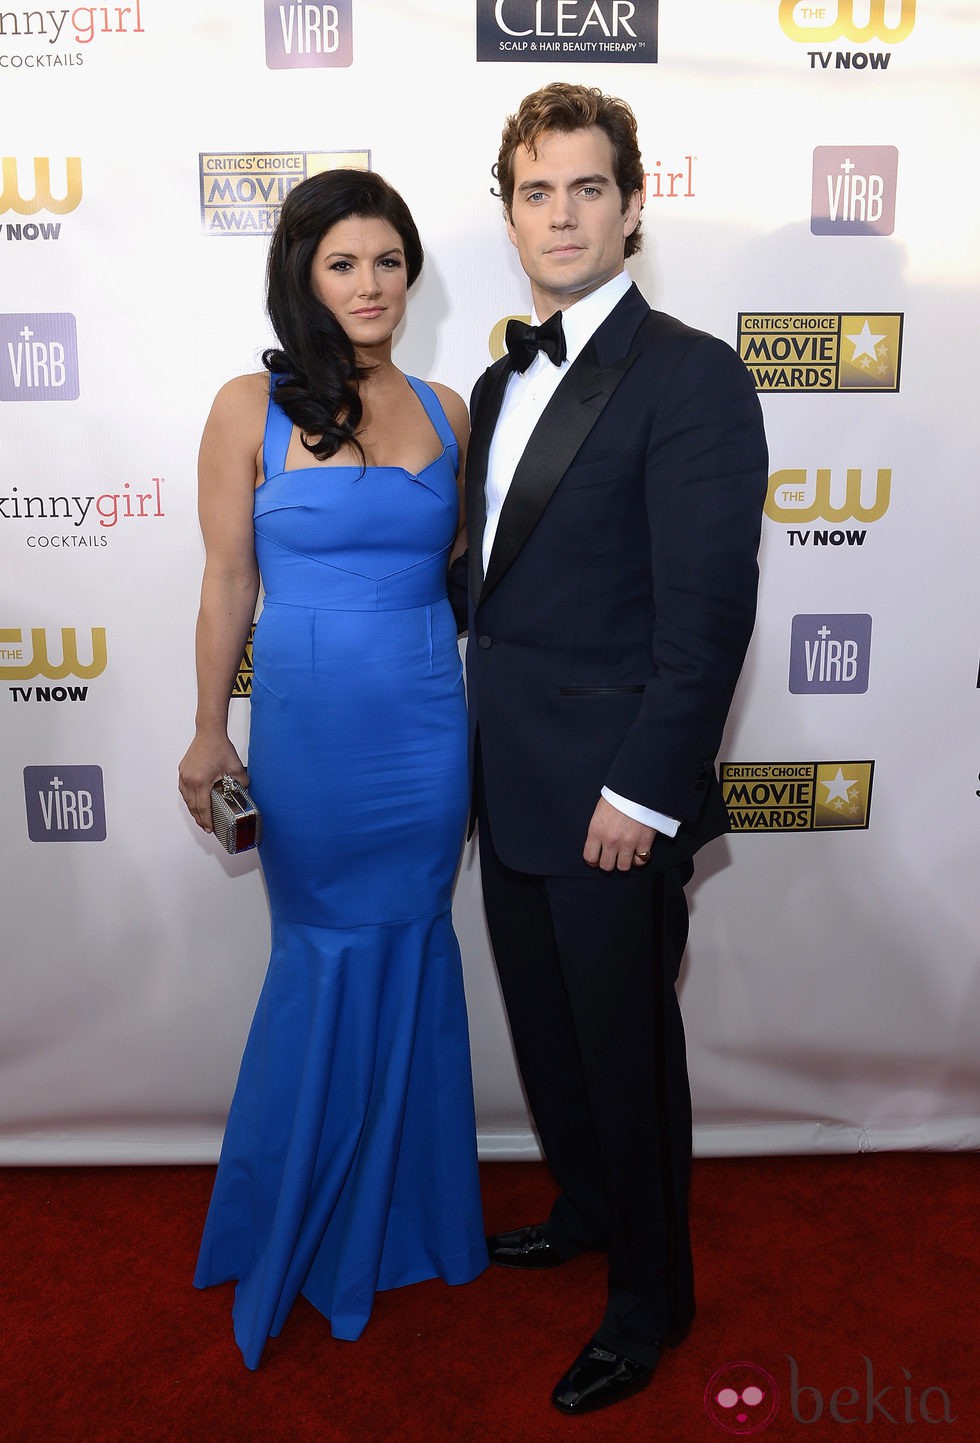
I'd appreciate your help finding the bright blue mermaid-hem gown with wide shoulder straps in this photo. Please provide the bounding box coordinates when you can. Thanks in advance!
[195,378,486,1368]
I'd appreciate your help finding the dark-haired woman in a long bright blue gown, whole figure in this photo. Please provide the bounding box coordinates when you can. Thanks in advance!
[180,170,486,1368]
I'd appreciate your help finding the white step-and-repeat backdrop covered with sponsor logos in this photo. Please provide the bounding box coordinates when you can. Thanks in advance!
[0,0,980,1163]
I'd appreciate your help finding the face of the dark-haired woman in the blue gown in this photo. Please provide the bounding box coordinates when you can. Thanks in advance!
[310,215,408,348]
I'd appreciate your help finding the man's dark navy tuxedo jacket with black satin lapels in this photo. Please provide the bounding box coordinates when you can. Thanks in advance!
[466,286,768,876]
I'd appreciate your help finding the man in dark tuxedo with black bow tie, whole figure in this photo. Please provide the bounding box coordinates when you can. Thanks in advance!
[468,84,766,1414]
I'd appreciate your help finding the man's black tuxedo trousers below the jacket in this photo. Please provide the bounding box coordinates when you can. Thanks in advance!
[479,784,694,1364]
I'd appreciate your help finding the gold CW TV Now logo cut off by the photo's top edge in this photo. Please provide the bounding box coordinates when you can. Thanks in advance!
[778,0,915,72]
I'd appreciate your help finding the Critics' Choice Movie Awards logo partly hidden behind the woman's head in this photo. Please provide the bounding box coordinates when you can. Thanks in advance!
[198,150,371,235]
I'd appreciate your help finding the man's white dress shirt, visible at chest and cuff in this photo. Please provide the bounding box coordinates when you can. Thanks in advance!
[484,271,680,837]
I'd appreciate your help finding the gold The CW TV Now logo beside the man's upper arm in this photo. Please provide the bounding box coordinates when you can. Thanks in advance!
[764,466,892,548]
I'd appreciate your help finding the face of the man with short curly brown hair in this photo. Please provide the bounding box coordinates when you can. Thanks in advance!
[507,126,639,320]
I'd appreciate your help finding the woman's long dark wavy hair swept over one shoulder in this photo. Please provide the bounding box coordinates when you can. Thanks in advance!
[263,170,424,462]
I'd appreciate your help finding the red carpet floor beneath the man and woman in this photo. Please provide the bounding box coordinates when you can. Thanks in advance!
[0,1153,980,1443]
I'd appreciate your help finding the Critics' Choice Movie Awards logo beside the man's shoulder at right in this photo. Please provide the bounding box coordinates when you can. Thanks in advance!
[739,310,904,392]
